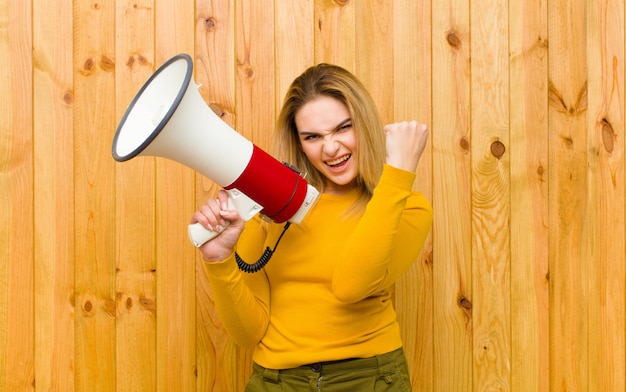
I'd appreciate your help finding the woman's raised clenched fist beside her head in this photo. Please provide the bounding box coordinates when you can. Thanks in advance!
[384,121,429,172]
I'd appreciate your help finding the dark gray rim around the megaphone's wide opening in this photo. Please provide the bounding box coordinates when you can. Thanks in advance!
[111,53,193,162]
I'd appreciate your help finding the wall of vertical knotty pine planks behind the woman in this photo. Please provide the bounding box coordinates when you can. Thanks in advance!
[0,0,626,392]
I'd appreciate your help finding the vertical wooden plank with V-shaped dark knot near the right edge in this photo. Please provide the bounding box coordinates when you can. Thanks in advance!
[548,1,588,391]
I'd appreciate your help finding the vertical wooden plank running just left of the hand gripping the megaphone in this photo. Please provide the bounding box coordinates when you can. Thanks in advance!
[155,0,197,392]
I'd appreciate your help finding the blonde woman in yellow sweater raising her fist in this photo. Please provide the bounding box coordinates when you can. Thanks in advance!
[192,64,432,392]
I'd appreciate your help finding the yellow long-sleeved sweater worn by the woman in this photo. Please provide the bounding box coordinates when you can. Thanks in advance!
[204,165,432,369]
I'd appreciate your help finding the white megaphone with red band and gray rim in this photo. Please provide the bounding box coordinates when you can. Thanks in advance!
[112,54,319,246]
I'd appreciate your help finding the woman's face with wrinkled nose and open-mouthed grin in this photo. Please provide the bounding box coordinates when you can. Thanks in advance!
[295,96,359,194]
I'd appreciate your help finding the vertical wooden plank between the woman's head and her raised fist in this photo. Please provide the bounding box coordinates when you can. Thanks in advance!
[355,0,394,123]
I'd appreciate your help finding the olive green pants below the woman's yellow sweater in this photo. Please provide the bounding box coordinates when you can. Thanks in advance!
[246,348,411,392]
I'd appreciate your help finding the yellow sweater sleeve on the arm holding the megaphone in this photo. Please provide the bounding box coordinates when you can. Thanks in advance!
[204,218,270,347]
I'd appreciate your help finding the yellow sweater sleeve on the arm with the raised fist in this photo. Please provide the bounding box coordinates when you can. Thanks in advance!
[332,165,433,302]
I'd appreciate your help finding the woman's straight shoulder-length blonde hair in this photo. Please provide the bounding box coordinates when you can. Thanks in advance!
[273,63,385,213]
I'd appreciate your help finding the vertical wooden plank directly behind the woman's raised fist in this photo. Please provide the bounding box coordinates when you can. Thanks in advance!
[393,0,433,391]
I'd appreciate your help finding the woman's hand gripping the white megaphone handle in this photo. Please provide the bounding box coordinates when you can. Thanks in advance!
[191,190,245,262]
